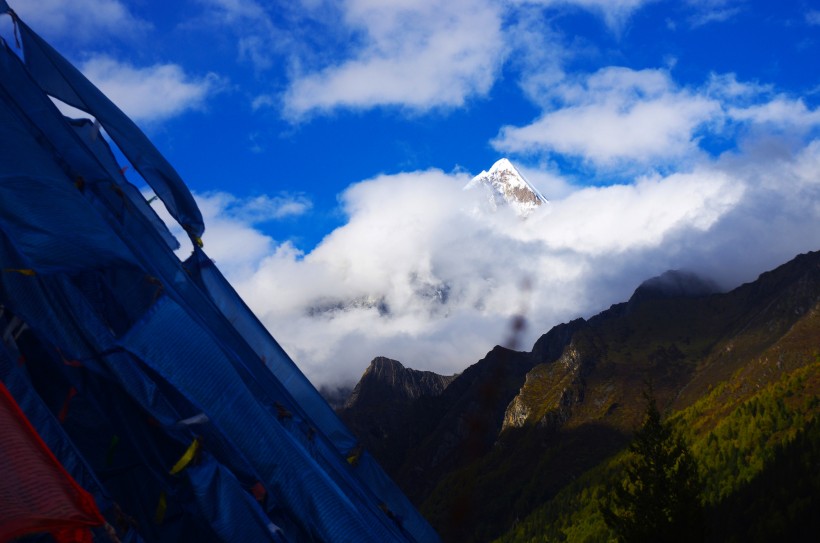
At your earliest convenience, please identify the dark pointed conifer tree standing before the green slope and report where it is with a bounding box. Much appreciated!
[601,387,704,543]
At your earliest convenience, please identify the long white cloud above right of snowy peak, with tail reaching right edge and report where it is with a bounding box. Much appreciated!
[492,67,820,171]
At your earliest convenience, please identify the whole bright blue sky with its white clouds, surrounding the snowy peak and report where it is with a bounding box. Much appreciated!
[3,0,820,384]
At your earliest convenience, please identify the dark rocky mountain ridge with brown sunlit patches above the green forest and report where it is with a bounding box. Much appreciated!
[338,252,820,541]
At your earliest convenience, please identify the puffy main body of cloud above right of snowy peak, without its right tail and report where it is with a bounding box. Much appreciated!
[493,67,720,167]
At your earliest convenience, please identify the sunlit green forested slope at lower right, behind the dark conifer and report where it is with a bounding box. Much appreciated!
[498,355,820,543]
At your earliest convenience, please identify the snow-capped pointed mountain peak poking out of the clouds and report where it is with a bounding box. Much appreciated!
[464,158,548,217]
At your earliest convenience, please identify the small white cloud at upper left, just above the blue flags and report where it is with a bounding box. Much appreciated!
[80,55,222,122]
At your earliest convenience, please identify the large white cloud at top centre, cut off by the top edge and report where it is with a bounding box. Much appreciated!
[284,0,506,118]
